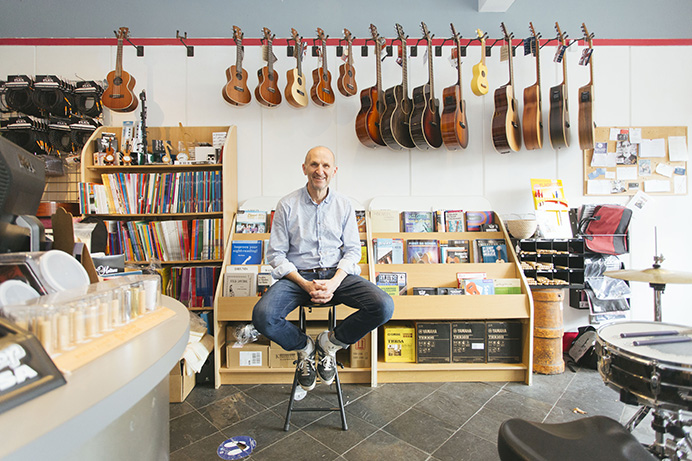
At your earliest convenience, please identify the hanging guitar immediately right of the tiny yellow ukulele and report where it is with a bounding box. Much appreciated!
[492,23,521,154]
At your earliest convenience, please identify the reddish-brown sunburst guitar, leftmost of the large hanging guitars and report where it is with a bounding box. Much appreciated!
[356,24,386,147]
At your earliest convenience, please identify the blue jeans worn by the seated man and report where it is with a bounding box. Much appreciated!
[252,269,394,351]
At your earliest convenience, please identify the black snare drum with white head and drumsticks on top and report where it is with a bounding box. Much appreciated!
[596,322,692,411]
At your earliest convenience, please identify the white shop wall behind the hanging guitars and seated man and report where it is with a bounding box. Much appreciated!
[0,38,692,329]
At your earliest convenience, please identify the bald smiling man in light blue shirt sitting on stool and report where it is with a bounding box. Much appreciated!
[252,146,394,390]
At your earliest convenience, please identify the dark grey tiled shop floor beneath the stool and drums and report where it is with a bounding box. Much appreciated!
[170,369,654,461]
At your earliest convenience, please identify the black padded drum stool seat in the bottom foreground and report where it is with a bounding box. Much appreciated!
[497,416,656,461]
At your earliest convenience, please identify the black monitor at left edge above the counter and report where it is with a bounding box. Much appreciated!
[0,136,46,253]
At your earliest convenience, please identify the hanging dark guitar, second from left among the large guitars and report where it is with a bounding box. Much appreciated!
[380,24,416,150]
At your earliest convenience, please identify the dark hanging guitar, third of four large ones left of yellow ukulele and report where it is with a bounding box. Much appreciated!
[409,22,442,149]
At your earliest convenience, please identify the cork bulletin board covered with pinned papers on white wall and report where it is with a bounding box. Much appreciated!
[584,126,689,195]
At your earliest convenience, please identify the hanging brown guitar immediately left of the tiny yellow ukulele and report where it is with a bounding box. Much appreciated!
[440,24,469,150]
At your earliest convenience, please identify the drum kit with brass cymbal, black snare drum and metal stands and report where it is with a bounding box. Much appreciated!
[596,256,692,460]
